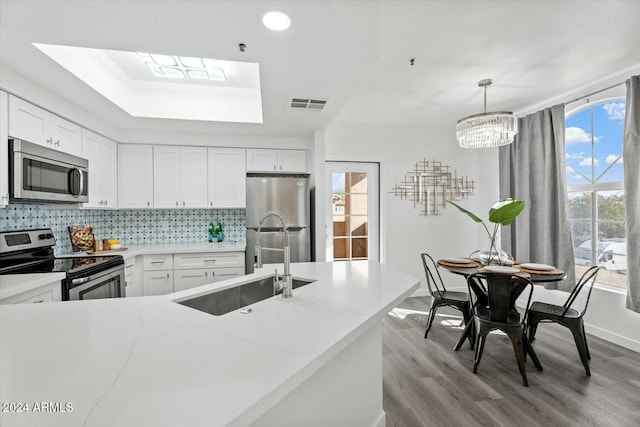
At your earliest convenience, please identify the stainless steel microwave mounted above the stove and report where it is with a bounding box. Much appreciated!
[9,139,89,203]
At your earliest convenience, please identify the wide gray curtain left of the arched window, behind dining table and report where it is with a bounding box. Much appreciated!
[499,105,575,290]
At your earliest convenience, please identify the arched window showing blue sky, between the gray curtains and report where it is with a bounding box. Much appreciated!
[565,99,627,288]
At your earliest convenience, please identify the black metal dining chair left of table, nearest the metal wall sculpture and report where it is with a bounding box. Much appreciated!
[420,253,474,350]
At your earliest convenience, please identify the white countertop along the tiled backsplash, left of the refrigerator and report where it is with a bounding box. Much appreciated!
[60,242,247,259]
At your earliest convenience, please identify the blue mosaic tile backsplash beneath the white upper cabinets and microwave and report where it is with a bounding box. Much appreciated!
[0,204,246,255]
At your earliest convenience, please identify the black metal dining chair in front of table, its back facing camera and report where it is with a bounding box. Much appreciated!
[467,273,542,386]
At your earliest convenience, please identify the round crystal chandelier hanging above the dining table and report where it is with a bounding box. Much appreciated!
[456,79,518,148]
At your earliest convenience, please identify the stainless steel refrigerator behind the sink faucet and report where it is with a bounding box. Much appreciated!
[246,175,311,274]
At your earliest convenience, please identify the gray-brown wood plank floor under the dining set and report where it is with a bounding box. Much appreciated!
[382,297,640,427]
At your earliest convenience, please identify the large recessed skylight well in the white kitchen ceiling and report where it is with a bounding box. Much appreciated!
[34,43,262,123]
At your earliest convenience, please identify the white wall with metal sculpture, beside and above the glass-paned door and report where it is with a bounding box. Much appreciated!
[325,122,498,293]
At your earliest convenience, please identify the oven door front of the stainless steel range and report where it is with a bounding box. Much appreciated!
[63,265,125,301]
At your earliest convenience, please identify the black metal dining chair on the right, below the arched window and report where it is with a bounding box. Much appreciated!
[527,266,600,376]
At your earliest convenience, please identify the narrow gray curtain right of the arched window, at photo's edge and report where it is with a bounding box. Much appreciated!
[622,76,640,313]
